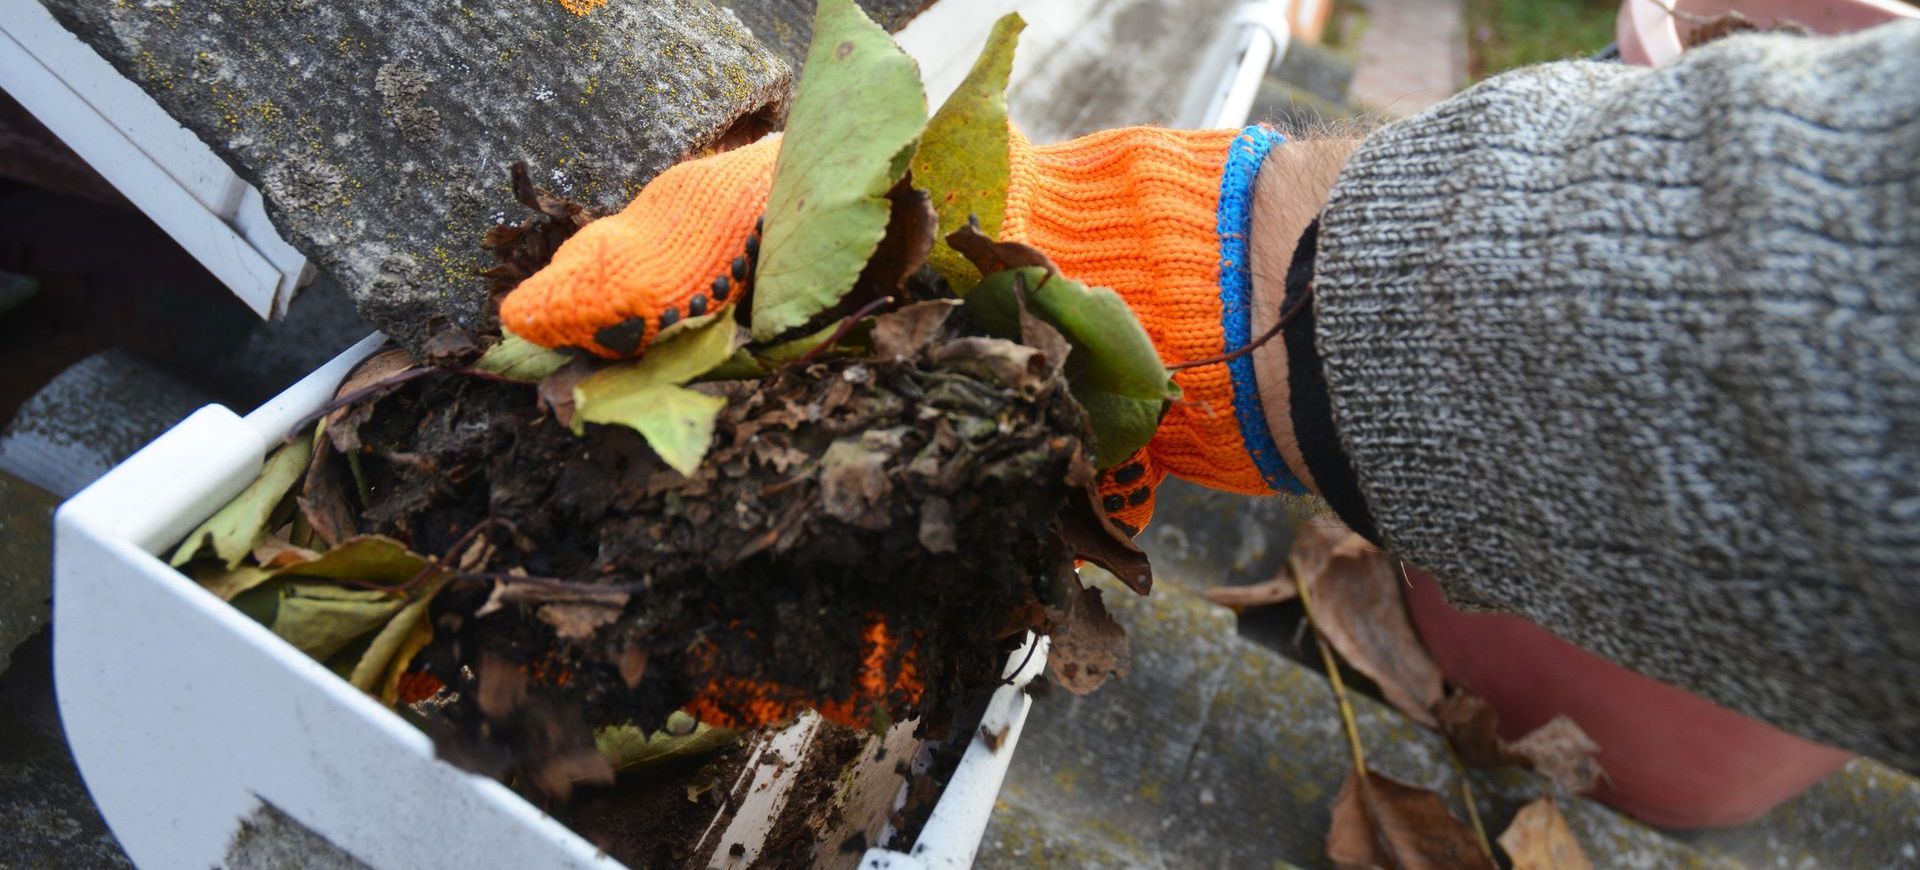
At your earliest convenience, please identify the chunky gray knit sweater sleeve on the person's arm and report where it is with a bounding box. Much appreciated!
[1313,21,1920,770]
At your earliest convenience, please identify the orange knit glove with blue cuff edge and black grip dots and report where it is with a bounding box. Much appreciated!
[501,127,1304,534]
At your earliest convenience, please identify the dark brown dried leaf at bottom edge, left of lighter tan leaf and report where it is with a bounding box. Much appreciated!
[1327,770,1494,870]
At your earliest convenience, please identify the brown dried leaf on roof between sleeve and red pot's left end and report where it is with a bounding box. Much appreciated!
[1288,522,1446,728]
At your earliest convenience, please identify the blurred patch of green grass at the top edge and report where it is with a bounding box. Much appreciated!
[1467,0,1619,81]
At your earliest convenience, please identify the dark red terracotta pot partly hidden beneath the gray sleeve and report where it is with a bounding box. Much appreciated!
[1407,568,1853,828]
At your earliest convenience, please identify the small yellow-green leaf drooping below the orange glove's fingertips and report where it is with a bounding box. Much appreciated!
[574,317,737,474]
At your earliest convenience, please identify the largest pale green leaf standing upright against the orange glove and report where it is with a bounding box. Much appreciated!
[753,0,927,342]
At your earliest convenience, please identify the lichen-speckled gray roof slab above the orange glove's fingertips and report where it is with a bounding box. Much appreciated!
[44,0,791,348]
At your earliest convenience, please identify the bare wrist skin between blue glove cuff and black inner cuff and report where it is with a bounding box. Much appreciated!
[1250,138,1359,494]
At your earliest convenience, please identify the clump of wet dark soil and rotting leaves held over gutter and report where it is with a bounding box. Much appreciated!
[301,163,1144,795]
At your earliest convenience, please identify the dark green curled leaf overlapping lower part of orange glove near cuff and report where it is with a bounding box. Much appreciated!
[966,267,1179,469]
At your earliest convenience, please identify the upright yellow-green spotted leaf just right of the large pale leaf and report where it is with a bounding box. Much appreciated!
[914,12,1027,296]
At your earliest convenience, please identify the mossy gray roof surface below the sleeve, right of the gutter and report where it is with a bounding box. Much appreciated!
[975,480,1920,870]
